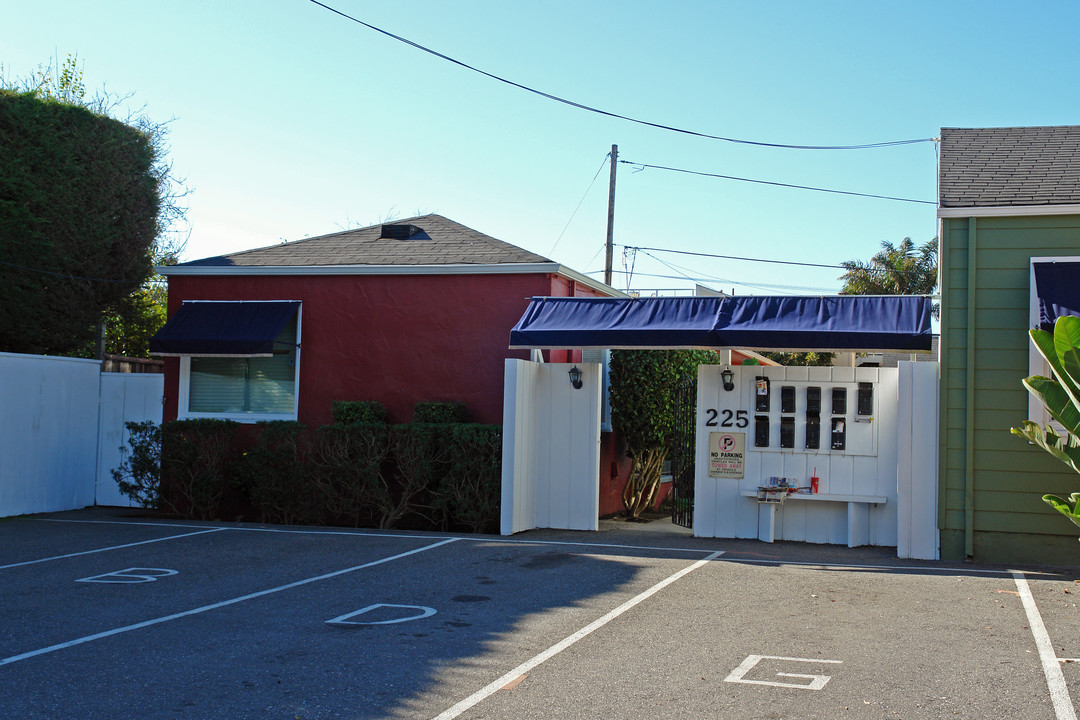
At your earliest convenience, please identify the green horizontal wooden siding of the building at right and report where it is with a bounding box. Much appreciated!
[939,216,1080,563]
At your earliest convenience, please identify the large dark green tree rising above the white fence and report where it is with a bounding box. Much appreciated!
[0,56,187,356]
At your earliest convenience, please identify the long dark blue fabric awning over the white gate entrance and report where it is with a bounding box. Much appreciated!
[510,296,931,352]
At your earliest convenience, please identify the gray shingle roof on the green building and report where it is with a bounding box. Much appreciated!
[939,125,1080,207]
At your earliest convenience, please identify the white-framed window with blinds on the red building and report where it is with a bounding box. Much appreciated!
[188,316,297,416]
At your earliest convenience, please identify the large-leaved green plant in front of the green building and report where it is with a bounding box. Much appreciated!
[1012,316,1080,535]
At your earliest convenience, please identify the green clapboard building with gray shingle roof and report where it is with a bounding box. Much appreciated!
[937,125,1080,565]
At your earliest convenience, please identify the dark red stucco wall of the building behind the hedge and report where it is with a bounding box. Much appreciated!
[164,273,609,426]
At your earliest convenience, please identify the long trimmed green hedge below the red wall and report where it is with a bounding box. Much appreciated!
[128,420,502,532]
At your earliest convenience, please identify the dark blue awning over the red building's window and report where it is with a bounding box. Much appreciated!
[150,300,300,357]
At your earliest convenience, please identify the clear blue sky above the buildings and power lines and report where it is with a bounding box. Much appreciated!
[0,0,1080,295]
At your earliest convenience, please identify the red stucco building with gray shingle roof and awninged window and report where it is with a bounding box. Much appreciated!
[153,215,622,426]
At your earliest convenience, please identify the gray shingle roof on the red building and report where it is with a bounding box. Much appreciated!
[177,215,551,268]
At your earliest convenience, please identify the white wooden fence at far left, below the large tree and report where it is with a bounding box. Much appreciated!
[0,353,164,517]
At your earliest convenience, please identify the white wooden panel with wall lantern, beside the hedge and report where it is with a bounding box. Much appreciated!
[502,359,602,534]
